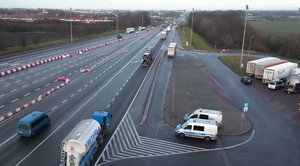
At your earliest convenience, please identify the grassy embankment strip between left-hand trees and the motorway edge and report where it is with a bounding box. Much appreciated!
[0,31,117,57]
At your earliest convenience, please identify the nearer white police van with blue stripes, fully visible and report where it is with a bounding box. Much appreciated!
[175,118,218,141]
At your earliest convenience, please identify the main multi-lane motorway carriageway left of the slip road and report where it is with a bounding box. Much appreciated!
[0,28,161,166]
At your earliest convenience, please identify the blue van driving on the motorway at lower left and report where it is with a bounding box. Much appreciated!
[18,111,50,137]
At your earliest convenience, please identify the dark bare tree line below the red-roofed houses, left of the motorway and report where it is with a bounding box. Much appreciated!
[0,11,151,51]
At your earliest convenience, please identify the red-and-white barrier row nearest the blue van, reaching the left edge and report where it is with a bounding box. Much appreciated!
[0,79,70,123]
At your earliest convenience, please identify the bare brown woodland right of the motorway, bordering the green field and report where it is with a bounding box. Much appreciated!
[188,11,300,60]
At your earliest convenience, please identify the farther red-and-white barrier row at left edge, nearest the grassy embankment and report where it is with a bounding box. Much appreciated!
[0,54,72,77]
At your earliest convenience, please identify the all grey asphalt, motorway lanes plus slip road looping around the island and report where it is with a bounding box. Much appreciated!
[0,24,300,166]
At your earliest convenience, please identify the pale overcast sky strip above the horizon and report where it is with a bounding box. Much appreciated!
[0,0,300,10]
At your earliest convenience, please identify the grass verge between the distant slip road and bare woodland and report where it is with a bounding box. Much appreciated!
[177,26,214,51]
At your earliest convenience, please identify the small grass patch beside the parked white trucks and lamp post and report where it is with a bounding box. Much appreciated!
[219,56,258,75]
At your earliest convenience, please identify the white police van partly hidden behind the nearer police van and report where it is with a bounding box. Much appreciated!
[184,108,223,127]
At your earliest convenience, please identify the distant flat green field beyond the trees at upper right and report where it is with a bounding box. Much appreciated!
[249,20,300,36]
